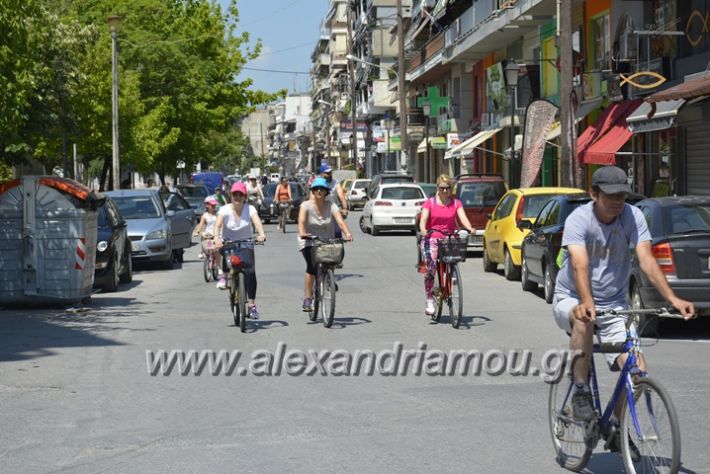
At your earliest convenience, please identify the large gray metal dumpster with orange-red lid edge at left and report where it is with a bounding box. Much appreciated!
[0,176,104,305]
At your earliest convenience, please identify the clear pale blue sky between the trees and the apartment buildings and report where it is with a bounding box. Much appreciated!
[219,0,330,97]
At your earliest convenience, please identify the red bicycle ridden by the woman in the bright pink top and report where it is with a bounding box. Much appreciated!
[424,229,468,328]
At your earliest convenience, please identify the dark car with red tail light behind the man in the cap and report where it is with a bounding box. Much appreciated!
[629,196,710,335]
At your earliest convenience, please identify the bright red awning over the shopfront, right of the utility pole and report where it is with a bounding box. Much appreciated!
[577,99,641,164]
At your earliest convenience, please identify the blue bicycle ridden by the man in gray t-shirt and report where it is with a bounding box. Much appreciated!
[548,308,681,473]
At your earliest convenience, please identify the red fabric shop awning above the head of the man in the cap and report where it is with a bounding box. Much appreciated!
[577,99,641,164]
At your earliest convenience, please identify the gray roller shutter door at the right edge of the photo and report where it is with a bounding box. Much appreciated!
[683,121,710,196]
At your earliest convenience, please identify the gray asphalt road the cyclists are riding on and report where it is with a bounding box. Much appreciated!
[0,213,710,474]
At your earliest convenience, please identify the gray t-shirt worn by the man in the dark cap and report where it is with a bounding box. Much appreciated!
[555,202,651,308]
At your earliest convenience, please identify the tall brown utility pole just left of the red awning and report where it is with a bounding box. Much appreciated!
[557,0,582,187]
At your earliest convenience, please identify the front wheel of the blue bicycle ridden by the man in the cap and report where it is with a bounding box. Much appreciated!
[620,377,680,474]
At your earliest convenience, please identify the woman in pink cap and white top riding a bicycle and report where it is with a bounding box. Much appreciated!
[215,182,266,319]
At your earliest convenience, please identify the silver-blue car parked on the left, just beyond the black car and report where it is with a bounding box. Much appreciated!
[106,189,195,263]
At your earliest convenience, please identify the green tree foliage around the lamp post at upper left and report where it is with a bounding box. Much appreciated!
[0,0,285,189]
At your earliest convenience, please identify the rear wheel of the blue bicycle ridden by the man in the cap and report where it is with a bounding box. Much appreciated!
[547,376,592,472]
